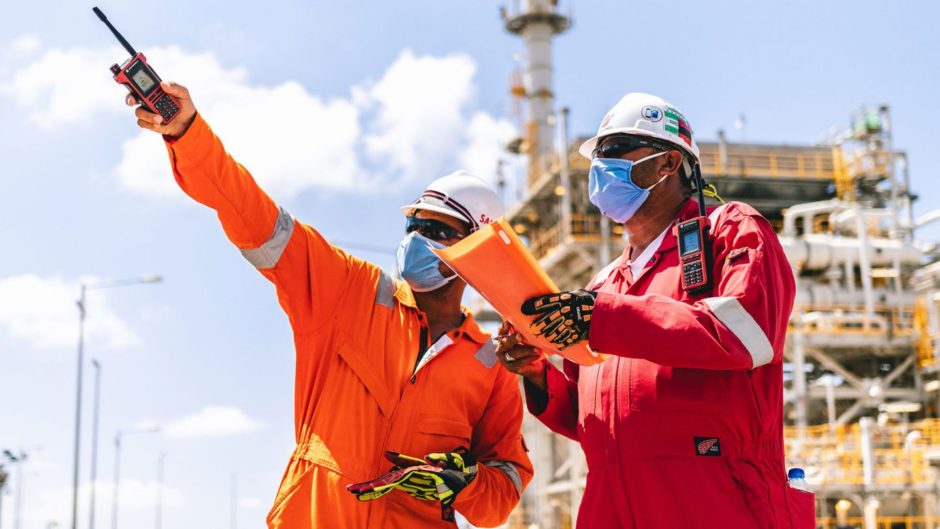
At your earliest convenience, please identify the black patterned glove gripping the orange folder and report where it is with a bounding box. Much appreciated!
[522,290,597,349]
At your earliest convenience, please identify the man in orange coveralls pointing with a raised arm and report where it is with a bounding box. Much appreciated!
[128,83,532,529]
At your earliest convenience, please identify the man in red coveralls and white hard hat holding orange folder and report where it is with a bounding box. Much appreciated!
[498,93,815,529]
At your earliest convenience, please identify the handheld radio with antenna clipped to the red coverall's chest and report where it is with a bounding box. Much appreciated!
[673,164,713,295]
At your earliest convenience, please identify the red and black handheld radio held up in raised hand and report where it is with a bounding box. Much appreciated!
[92,7,180,123]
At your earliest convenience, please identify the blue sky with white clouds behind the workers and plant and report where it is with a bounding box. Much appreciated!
[0,0,940,529]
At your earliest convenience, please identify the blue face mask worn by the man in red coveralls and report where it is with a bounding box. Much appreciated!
[588,152,669,224]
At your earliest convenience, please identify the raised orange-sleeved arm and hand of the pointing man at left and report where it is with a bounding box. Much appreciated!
[129,83,368,329]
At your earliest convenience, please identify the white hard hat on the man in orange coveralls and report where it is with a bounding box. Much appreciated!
[401,170,503,232]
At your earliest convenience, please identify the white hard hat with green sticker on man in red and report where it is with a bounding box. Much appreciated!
[578,92,699,168]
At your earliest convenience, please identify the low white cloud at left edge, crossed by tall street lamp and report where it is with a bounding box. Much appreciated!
[0,274,140,348]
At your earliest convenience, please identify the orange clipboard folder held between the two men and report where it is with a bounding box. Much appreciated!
[434,217,606,366]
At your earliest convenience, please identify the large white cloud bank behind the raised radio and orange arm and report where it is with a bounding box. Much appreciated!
[0,42,511,199]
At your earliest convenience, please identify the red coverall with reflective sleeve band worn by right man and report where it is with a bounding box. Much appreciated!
[526,200,815,529]
